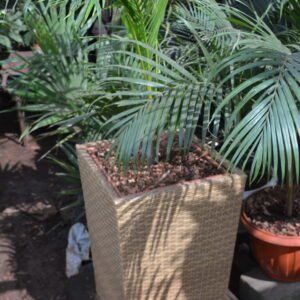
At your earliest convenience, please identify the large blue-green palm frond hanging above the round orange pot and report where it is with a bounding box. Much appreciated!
[213,45,300,182]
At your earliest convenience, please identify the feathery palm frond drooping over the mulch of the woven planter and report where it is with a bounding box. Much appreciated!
[105,42,221,168]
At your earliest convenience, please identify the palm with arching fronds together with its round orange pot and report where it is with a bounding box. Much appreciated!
[210,1,300,281]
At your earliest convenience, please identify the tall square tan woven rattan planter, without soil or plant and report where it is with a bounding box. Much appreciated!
[77,144,246,300]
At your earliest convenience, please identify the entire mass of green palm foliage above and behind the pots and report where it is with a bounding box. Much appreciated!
[0,0,300,214]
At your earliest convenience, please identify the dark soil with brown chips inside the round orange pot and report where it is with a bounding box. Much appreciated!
[245,187,300,236]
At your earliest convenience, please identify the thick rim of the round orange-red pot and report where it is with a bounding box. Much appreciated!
[241,206,300,247]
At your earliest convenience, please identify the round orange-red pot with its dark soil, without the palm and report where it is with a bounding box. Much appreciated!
[241,187,300,282]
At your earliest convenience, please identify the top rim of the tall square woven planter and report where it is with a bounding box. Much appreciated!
[76,142,246,200]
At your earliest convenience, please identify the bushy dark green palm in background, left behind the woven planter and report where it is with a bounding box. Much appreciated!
[12,1,112,152]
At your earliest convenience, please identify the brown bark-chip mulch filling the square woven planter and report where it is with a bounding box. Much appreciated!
[87,141,226,196]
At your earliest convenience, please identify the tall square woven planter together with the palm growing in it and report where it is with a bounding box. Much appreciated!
[77,1,246,300]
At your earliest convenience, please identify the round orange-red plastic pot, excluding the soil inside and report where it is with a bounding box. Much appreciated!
[241,209,300,282]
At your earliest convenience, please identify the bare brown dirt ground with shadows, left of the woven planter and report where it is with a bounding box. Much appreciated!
[0,106,70,300]
